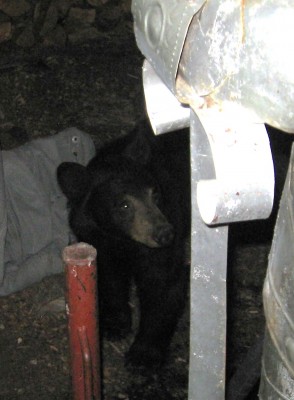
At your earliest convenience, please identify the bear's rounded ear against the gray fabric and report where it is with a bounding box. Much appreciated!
[57,162,90,202]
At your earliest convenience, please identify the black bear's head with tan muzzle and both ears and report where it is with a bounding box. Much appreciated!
[57,125,174,248]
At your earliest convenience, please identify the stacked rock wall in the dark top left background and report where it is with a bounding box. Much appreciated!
[0,0,131,48]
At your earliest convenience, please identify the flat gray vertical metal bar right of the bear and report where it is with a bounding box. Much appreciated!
[189,111,228,400]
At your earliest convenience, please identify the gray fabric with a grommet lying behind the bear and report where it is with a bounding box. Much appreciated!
[0,128,95,296]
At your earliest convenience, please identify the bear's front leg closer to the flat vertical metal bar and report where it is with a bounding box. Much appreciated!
[126,267,187,368]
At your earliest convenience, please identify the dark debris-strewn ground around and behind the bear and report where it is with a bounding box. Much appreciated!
[0,3,292,400]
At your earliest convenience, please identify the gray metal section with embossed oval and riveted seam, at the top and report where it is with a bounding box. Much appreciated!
[132,0,205,91]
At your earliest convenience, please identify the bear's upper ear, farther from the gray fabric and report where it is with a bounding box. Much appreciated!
[123,120,154,165]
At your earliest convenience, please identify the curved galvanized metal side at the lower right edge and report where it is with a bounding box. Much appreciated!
[259,147,294,400]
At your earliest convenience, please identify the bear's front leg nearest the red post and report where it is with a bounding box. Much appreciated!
[98,267,132,339]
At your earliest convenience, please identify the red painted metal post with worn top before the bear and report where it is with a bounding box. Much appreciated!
[63,243,101,400]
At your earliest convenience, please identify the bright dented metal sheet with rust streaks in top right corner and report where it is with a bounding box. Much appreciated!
[177,0,294,133]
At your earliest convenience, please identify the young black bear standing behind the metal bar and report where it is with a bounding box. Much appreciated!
[57,123,190,367]
